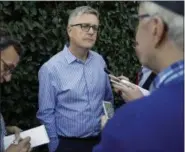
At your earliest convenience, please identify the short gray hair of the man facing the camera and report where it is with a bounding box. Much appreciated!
[68,6,99,25]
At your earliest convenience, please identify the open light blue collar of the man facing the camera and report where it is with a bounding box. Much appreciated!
[63,44,93,64]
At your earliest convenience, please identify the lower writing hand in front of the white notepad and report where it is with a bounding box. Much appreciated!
[5,137,31,152]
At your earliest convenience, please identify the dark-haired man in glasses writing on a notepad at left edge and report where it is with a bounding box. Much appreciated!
[0,30,30,152]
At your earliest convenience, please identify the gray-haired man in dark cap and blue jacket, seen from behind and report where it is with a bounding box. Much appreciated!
[93,1,184,152]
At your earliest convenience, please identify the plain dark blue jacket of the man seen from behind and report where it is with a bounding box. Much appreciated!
[93,80,184,152]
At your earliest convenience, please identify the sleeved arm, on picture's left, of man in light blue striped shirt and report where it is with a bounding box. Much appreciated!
[37,65,59,152]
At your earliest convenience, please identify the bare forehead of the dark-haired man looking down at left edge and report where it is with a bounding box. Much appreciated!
[1,46,20,63]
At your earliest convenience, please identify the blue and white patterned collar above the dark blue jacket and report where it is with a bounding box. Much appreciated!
[153,60,184,89]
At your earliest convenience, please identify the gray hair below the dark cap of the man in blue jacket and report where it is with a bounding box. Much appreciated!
[140,2,184,50]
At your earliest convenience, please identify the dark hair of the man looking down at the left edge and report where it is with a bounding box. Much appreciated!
[0,29,23,56]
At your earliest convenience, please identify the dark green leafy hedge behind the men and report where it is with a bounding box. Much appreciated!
[0,1,139,151]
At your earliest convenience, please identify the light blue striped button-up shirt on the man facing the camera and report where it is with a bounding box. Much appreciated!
[37,46,113,151]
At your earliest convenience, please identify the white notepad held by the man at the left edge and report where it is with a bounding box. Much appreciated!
[4,125,49,149]
